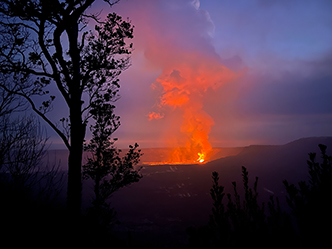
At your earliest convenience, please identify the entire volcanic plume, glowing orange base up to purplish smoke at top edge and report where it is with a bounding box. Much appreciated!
[116,0,238,164]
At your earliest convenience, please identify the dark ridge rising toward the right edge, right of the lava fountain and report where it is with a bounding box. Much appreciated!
[206,137,332,200]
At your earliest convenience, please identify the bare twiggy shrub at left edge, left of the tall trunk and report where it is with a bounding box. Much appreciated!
[0,71,59,197]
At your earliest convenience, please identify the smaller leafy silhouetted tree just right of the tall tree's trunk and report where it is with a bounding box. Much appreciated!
[83,98,142,230]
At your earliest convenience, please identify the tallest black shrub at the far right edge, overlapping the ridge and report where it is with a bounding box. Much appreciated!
[284,144,332,248]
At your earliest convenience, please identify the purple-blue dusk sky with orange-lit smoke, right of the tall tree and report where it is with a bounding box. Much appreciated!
[49,0,332,148]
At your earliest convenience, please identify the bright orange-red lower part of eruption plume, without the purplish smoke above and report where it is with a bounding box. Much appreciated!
[149,53,236,164]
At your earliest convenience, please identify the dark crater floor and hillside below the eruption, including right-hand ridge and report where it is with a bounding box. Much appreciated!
[106,137,332,245]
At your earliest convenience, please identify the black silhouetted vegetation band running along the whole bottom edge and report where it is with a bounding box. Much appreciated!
[0,145,332,248]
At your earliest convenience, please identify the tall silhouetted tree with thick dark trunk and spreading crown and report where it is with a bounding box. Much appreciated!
[0,0,133,216]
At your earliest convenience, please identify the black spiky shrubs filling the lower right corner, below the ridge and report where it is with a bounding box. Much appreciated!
[187,144,332,248]
